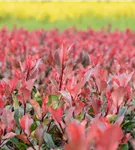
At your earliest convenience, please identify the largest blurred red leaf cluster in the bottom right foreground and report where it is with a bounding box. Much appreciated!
[87,118,123,150]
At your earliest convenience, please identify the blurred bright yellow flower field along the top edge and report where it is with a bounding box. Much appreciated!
[0,0,135,21]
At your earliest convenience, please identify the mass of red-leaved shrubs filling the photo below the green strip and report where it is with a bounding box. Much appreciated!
[0,28,135,150]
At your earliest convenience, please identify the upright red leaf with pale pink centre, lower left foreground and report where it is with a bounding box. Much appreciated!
[19,114,33,136]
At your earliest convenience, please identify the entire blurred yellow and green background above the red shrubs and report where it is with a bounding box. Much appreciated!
[0,0,135,30]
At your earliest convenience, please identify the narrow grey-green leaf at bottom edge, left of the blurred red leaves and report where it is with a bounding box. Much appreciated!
[44,132,56,148]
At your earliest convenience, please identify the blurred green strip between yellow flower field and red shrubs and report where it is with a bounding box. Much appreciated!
[0,17,135,30]
